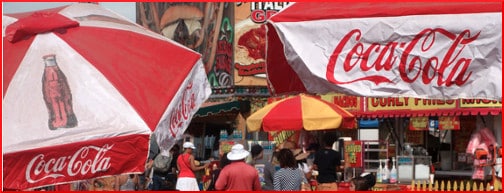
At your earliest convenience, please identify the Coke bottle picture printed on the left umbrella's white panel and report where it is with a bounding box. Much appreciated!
[42,54,77,130]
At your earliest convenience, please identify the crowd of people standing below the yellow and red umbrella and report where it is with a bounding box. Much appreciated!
[141,132,374,191]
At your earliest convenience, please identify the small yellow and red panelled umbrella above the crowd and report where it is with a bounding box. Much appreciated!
[247,94,356,132]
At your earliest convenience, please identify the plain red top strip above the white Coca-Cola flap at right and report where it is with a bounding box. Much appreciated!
[270,1,502,22]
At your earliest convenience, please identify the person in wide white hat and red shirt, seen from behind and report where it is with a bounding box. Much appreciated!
[215,144,261,191]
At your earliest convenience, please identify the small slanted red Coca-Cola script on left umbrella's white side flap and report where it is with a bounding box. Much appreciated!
[170,82,196,137]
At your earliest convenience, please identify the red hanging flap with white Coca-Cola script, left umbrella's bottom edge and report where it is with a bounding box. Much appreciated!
[3,135,149,189]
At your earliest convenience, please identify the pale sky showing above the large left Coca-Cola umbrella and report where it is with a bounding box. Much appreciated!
[2,2,136,22]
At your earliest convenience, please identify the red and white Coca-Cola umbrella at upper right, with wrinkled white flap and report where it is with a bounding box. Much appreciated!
[266,2,502,101]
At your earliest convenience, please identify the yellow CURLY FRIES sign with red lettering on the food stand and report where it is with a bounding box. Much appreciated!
[367,97,457,111]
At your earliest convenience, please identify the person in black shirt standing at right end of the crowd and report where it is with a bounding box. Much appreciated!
[313,134,341,191]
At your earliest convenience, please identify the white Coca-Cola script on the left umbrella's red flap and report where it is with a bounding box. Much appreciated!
[25,144,114,183]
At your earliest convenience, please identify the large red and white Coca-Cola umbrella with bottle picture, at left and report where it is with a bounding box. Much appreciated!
[2,3,211,189]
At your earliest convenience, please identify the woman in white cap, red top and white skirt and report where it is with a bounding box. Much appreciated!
[176,142,210,191]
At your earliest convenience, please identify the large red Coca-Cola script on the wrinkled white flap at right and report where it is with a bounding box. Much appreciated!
[326,28,480,87]
